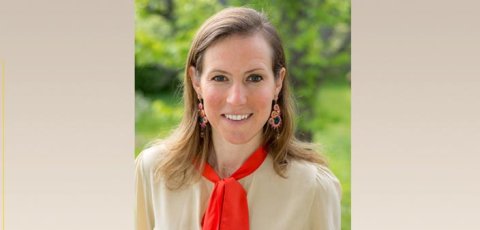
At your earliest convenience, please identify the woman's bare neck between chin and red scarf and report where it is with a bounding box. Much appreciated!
[208,131,261,178]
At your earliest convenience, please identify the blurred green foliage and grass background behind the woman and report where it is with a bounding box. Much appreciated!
[135,0,351,230]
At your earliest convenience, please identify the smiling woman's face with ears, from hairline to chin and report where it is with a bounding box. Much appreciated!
[189,34,285,144]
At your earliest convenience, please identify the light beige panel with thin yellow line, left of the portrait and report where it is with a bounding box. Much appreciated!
[0,0,134,230]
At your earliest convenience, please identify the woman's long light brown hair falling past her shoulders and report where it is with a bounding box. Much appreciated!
[155,7,326,189]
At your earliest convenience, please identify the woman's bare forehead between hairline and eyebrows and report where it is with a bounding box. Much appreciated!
[203,33,273,71]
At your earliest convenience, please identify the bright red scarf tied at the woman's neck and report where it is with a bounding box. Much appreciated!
[202,146,267,230]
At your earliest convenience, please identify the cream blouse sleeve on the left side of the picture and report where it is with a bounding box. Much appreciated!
[135,151,154,230]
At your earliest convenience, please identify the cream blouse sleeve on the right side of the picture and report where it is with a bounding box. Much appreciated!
[310,166,342,230]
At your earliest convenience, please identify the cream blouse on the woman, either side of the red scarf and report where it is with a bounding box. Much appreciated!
[135,147,341,230]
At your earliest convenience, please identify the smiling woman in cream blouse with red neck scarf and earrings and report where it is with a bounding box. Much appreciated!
[136,8,340,230]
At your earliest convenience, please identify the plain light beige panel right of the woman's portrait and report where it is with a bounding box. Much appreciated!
[352,0,480,230]
